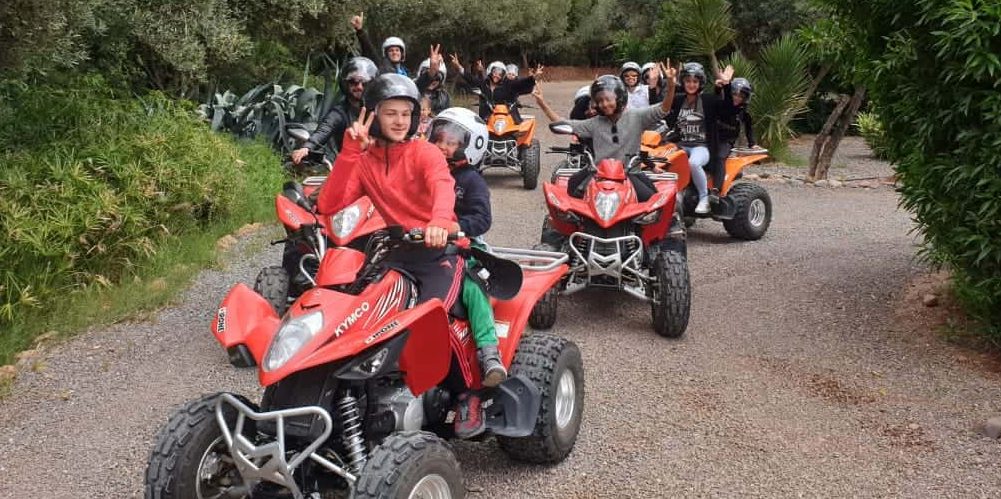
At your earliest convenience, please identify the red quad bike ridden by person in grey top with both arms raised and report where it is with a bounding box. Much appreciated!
[538,124,692,338]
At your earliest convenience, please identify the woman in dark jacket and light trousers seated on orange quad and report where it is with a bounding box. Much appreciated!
[665,62,733,214]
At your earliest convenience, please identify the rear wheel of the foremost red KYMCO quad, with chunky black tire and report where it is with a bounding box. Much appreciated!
[496,333,584,464]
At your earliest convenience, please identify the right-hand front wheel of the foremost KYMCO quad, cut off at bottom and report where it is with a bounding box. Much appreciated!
[351,431,465,499]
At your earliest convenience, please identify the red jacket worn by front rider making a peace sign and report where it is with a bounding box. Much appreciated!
[316,134,455,230]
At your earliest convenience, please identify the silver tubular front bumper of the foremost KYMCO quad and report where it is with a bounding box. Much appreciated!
[215,393,357,499]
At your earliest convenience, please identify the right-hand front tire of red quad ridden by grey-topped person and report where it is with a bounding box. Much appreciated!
[651,250,692,338]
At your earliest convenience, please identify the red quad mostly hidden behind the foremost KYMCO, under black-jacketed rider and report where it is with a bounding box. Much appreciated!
[253,170,385,315]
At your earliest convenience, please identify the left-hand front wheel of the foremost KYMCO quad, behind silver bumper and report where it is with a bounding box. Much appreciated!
[143,394,257,499]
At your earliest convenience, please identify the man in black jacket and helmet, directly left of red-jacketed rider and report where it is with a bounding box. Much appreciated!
[291,57,378,164]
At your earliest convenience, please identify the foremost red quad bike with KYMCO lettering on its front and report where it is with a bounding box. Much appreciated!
[145,227,584,498]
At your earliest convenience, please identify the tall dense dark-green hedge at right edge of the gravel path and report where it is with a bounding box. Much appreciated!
[830,0,1001,339]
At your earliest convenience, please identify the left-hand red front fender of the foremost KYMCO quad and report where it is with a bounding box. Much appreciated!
[212,283,280,364]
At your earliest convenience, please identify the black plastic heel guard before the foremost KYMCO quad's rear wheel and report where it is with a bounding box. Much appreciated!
[483,374,543,437]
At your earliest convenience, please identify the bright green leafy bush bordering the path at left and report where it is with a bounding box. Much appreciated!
[0,79,281,363]
